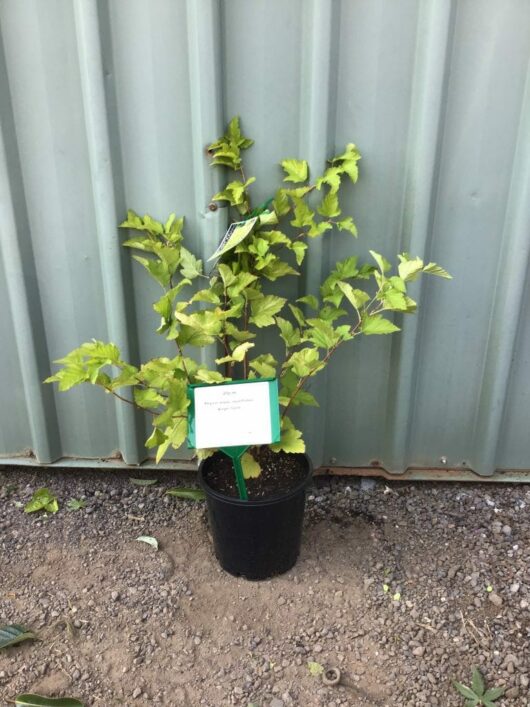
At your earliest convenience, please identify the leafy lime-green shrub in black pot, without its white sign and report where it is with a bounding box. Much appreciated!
[46,118,450,579]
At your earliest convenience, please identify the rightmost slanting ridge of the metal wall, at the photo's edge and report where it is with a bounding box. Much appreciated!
[471,64,530,476]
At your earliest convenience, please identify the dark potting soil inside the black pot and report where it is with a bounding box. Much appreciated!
[204,447,307,500]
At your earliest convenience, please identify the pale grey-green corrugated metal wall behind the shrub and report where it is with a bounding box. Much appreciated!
[0,0,530,475]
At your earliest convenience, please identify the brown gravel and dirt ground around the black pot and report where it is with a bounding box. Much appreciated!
[0,469,530,707]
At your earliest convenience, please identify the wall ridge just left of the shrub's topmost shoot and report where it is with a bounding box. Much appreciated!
[186,0,224,374]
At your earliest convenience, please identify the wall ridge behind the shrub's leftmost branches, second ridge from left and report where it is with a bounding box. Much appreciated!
[74,0,145,464]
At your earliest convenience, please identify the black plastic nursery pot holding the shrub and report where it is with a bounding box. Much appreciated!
[199,455,313,580]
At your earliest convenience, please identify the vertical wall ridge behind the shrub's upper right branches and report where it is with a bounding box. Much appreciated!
[299,0,334,466]
